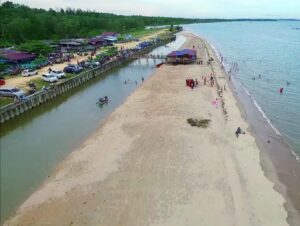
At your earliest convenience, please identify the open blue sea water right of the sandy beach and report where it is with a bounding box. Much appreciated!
[184,21,300,156]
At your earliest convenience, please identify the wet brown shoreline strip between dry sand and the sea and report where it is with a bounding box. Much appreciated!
[194,34,300,226]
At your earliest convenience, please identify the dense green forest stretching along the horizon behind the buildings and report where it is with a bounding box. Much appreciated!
[0,1,276,47]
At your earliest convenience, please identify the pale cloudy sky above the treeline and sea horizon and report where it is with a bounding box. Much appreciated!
[6,0,300,19]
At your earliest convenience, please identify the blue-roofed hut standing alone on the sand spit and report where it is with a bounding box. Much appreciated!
[166,49,197,64]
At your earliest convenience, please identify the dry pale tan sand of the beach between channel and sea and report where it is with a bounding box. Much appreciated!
[5,33,287,226]
